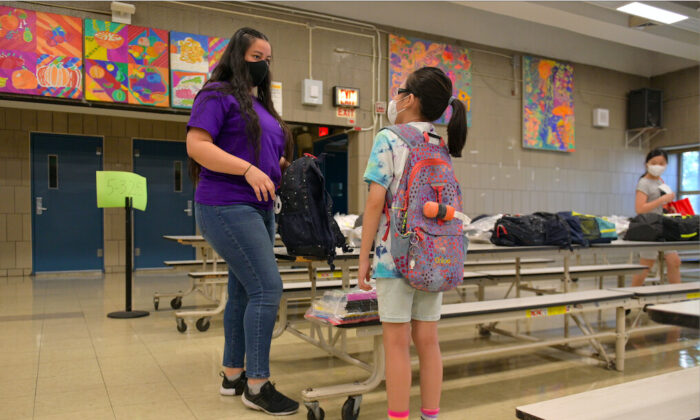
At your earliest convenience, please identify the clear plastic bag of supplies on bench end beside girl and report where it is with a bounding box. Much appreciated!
[304,288,379,325]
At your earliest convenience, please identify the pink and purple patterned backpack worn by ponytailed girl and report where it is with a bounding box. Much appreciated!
[384,124,469,292]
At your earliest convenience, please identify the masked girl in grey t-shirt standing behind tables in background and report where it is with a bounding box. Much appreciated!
[632,149,681,287]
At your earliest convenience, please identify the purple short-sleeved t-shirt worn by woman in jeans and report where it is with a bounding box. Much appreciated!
[187,84,285,209]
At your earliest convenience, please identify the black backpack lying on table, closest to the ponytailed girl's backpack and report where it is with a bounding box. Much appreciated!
[491,215,545,246]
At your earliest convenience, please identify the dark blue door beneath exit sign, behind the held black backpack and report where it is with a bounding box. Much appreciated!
[314,134,348,214]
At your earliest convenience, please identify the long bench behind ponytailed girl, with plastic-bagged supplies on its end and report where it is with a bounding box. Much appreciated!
[302,290,633,420]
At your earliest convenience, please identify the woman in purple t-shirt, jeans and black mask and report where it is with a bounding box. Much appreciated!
[187,28,299,415]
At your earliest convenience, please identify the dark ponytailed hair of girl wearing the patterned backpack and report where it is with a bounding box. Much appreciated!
[406,67,467,157]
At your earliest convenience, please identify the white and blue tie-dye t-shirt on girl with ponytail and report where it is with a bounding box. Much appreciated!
[364,122,435,278]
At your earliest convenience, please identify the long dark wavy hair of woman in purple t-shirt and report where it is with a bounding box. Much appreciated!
[189,28,294,184]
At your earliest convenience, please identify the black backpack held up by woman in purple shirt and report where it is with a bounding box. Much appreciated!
[278,155,350,269]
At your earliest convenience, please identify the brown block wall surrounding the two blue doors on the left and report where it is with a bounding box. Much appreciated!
[0,108,185,276]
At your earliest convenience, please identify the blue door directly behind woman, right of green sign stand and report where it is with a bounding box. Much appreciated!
[133,139,195,268]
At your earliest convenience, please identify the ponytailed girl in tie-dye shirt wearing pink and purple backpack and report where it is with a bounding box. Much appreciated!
[358,67,467,420]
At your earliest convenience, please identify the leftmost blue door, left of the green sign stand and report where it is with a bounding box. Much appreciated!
[30,133,104,273]
